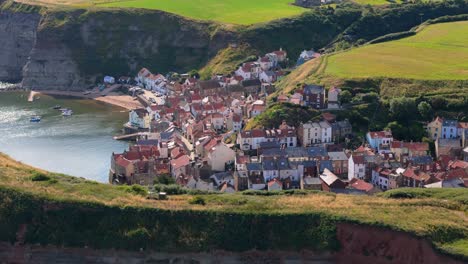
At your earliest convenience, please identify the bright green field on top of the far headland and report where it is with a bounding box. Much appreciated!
[97,0,306,25]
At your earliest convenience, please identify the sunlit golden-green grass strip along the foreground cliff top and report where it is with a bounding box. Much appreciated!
[0,154,468,256]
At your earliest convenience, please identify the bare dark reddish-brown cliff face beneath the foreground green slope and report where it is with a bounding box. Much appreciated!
[0,223,461,264]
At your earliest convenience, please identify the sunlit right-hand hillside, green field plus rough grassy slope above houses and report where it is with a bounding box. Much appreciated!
[276,21,468,98]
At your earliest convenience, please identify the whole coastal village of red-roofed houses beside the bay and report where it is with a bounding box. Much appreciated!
[106,49,468,194]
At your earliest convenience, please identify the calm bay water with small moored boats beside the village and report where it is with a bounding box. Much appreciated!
[0,92,128,182]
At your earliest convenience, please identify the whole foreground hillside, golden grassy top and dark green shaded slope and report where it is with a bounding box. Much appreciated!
[0,155,468,261]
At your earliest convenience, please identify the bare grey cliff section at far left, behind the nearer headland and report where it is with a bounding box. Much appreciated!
[0,11,40,82]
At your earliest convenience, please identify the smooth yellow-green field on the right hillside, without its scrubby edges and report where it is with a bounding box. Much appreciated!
[324,21,468,80]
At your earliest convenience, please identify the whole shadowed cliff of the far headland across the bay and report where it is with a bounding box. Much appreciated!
[0,5,235,90]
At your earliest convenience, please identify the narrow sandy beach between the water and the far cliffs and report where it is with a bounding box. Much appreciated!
[33,90,143,110]
